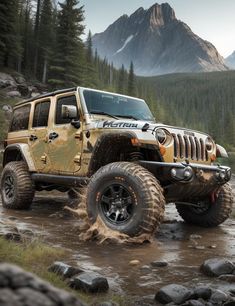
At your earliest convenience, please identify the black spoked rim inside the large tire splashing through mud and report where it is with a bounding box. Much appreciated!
[99,183,134,225]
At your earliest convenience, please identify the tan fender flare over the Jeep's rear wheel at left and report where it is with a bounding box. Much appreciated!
[3,143,36,172]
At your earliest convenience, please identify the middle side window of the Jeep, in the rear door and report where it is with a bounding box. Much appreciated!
[33,101,50,127]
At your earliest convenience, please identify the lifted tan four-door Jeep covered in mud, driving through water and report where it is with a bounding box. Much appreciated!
[1,87,233,236]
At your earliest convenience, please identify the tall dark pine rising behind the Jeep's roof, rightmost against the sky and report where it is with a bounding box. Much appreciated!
[49,0,84,88]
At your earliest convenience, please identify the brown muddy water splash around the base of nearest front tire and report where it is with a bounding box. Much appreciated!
[64,188,153,244]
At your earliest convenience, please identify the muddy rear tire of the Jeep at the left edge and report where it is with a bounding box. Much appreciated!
[1,161,34,209]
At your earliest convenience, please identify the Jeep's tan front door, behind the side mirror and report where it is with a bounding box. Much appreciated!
[47,93,82,174]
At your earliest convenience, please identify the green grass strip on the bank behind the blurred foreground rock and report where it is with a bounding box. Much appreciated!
[0,237,128,306]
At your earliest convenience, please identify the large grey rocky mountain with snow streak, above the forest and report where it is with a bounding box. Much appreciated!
[92,3,228,76]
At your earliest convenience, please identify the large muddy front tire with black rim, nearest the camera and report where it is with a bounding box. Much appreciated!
[87,162,165,236]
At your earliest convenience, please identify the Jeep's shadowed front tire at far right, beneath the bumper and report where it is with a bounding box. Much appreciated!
[176,183,233,227]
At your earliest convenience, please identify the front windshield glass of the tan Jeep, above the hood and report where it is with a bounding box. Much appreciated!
[83,90,154,121]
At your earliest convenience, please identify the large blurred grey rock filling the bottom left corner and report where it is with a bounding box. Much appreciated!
[0,264,84,306]
